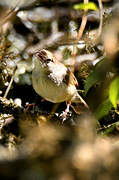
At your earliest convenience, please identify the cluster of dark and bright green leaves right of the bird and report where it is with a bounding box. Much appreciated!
[84,60,119,120]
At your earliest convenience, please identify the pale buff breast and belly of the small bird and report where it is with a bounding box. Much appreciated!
[32,68,76,103]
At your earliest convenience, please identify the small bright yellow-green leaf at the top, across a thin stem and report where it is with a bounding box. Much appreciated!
[74,2,98,11]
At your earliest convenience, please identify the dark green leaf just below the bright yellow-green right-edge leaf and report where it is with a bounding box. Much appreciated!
[95,99,113,120]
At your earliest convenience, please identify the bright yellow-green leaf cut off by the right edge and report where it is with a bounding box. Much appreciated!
[109,76,119,108]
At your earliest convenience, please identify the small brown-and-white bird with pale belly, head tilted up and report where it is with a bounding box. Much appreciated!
[32,49,89,116]
